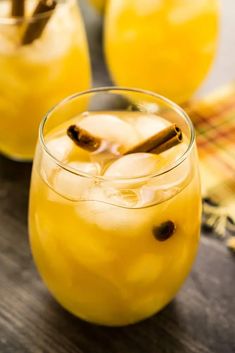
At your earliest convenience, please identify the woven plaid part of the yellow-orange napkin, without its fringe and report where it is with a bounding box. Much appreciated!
[186,84,235,219]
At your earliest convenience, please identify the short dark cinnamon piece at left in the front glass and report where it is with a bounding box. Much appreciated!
[67,125,102,152]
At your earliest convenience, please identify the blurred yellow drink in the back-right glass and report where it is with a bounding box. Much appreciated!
[104,0,218,103]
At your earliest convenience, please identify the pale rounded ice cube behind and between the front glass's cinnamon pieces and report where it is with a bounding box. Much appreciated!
[79,112,140,148]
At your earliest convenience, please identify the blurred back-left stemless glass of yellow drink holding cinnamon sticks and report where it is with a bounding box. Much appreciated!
[0,0,90,160]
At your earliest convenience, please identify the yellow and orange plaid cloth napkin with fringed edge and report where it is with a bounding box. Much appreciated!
[185,83,235,250]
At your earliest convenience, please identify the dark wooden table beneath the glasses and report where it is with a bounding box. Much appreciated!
[0,0,235,353]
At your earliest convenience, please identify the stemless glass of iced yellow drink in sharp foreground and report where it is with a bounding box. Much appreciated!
[29,88,201,326]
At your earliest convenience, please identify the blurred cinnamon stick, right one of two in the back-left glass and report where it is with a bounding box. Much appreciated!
[21,0,57,45]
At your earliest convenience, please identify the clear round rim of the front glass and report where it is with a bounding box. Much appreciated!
[39,86,195,182]
